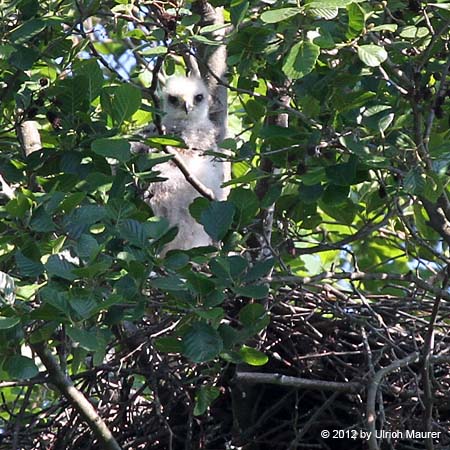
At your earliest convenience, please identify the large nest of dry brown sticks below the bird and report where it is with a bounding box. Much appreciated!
[0,283,450,450]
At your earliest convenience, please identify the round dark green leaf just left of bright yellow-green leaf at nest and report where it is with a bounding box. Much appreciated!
[183,322,223,363]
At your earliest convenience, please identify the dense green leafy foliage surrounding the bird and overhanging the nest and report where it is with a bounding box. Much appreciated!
[0,0,450,448]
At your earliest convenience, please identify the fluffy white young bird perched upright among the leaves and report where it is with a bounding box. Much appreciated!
[144,76,231,255]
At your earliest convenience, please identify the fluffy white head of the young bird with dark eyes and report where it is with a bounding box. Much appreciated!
[163,76,209,122]
